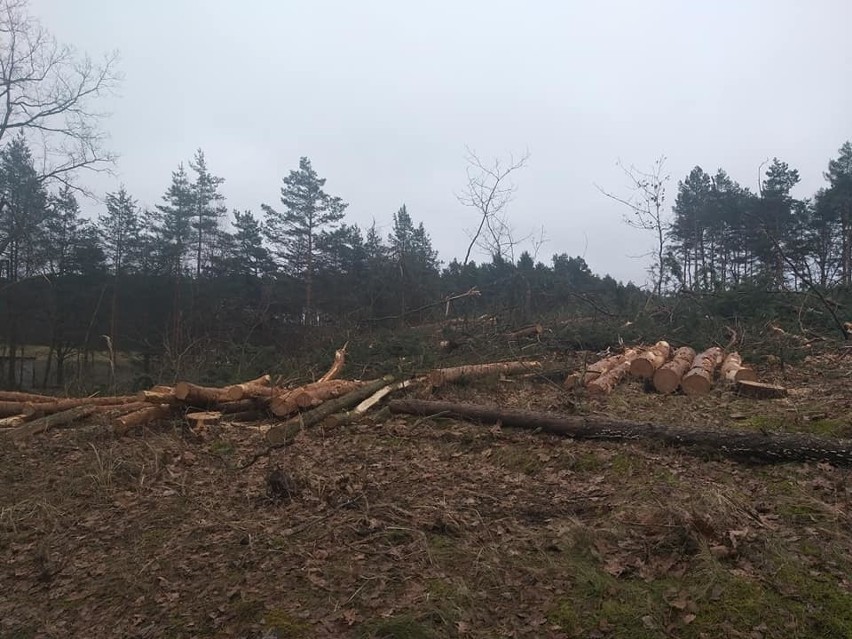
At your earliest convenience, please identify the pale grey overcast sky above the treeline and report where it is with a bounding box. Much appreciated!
[32,0,852,283]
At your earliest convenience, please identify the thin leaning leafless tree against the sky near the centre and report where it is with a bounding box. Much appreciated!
[456,148,530,264]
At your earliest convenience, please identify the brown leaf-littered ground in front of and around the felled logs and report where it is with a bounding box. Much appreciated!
[0,354,852,639]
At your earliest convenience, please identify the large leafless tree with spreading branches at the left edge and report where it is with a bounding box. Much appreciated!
[0,0,120,253]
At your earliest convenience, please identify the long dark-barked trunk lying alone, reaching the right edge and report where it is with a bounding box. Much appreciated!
[390,399,852,466]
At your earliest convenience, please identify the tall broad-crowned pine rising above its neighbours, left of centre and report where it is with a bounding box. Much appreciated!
[263,157,348,323]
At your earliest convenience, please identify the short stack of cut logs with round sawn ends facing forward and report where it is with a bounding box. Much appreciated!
[565,342,786,398]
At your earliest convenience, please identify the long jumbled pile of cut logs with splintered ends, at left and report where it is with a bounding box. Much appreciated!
[0,347,541,443]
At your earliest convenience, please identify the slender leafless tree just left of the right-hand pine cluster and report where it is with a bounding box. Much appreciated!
[595,155,671,295]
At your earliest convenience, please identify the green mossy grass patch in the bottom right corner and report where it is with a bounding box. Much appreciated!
[548,553,852,639]
